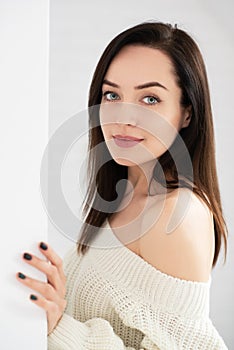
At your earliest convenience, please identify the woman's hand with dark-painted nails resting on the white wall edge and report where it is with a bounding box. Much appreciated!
[16,242,67,334]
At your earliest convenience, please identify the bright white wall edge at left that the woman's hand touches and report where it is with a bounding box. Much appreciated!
[0,0,49,350]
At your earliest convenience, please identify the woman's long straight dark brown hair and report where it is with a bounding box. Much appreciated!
[77,21,228,267]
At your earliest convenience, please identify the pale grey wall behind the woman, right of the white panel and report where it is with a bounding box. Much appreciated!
[49,0,234,349]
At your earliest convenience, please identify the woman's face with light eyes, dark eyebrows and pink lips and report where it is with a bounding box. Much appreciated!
[100,45,190,166]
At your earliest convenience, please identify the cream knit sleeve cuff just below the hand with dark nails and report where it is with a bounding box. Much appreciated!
[47,248,152,350]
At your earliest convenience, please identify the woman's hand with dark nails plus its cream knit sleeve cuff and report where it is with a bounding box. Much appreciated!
[16,243,148,350]
